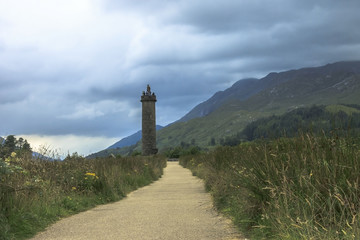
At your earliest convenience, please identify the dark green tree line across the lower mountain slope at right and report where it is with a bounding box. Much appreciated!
[220,104,360,146]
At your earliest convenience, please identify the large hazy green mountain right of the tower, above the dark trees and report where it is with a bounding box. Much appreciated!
[157,61,360,150]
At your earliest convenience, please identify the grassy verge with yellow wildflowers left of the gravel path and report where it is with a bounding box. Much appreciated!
[0,153,166,239]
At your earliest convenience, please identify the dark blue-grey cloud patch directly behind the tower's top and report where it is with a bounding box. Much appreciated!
[72,67,214,114]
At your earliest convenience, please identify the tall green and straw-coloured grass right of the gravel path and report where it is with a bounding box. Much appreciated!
[180,134,360,239]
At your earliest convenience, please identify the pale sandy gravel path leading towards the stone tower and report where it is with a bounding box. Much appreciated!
[33,162,242,240]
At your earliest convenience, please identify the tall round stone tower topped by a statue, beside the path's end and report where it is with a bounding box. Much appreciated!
[141,85,158,156]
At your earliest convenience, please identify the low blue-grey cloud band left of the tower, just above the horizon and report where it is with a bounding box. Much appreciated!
[0,98,139,136]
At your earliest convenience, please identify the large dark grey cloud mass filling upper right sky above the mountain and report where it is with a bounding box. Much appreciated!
[128,0,360,76]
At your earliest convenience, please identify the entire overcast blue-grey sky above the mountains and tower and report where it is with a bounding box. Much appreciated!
[0,0,360,155]
